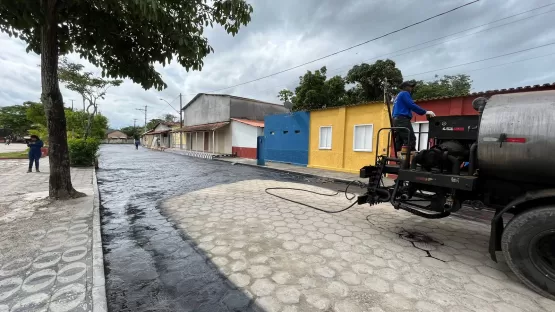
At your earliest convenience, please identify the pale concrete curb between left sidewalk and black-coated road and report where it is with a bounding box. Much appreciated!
[92,170,108,312]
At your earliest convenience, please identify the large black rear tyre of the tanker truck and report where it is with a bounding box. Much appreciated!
[501,206,555,300]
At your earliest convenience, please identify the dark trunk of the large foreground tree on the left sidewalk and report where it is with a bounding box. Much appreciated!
[41,0,85,199]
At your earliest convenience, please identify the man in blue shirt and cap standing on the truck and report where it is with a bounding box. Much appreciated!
[393,81,435,151]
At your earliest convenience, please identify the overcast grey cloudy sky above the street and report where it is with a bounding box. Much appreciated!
[0,0,555,128]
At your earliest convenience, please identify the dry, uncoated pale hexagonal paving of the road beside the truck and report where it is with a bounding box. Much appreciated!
[164,180,555,312]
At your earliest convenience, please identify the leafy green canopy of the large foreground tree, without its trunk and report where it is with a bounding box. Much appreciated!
[0,0,253,90]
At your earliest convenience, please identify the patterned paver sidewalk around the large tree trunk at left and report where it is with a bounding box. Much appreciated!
[0,159,96,312]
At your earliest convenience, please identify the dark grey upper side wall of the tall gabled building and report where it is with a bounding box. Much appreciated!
[229,97,288,120]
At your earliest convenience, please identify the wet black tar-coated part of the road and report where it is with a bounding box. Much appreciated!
[97,145,352,312]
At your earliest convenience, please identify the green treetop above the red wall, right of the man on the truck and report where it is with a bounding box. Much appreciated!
[412,74,472,100]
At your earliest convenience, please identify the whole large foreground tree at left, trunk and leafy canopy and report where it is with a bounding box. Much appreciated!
[0,0,252,199]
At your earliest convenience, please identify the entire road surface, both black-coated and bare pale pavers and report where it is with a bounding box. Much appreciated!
[97,146,555,312]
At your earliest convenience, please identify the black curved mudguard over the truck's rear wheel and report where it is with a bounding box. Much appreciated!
[489,189,555,262]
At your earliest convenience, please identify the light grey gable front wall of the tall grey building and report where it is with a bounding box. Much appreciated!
[183,94,230,126]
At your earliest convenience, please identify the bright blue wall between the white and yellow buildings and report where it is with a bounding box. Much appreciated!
[264,112,310,166]
